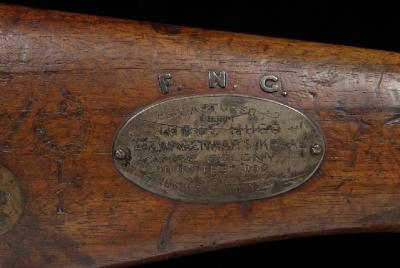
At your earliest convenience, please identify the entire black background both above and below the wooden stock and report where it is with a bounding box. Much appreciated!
[1,0,400,268]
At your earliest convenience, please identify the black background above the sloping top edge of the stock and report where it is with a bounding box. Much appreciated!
[0,0,400,51]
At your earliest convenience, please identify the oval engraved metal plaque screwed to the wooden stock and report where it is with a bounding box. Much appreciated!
[113,95,325,203]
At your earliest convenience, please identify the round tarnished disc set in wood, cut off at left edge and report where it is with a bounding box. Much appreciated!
[0,166,25,234]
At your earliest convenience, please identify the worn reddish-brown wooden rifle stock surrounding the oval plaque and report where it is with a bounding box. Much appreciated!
[0,5,400,267]
